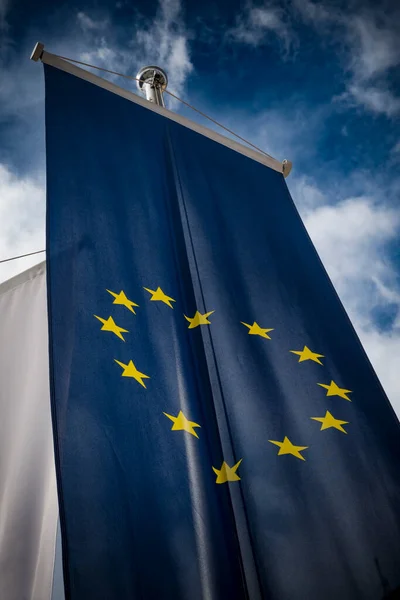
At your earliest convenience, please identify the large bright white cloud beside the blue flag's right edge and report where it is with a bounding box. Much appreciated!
[292,177,400,408]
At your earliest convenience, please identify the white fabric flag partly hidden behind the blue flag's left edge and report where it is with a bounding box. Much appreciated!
[0,263,58,600]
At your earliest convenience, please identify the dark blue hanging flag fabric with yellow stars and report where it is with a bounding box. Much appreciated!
[45,66,400,600]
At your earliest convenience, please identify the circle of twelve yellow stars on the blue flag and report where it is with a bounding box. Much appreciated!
[94,287,352,484]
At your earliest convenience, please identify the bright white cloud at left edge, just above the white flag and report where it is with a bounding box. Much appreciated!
[0,163,45,281]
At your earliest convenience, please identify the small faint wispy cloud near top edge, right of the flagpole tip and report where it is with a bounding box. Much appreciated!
[226,5,295,53]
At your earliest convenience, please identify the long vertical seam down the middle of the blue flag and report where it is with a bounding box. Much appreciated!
[167,127,262,600]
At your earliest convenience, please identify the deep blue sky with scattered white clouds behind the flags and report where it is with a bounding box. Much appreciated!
[0,0,400,408]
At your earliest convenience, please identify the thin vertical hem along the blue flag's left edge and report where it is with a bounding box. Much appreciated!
[44,65,71,600]
